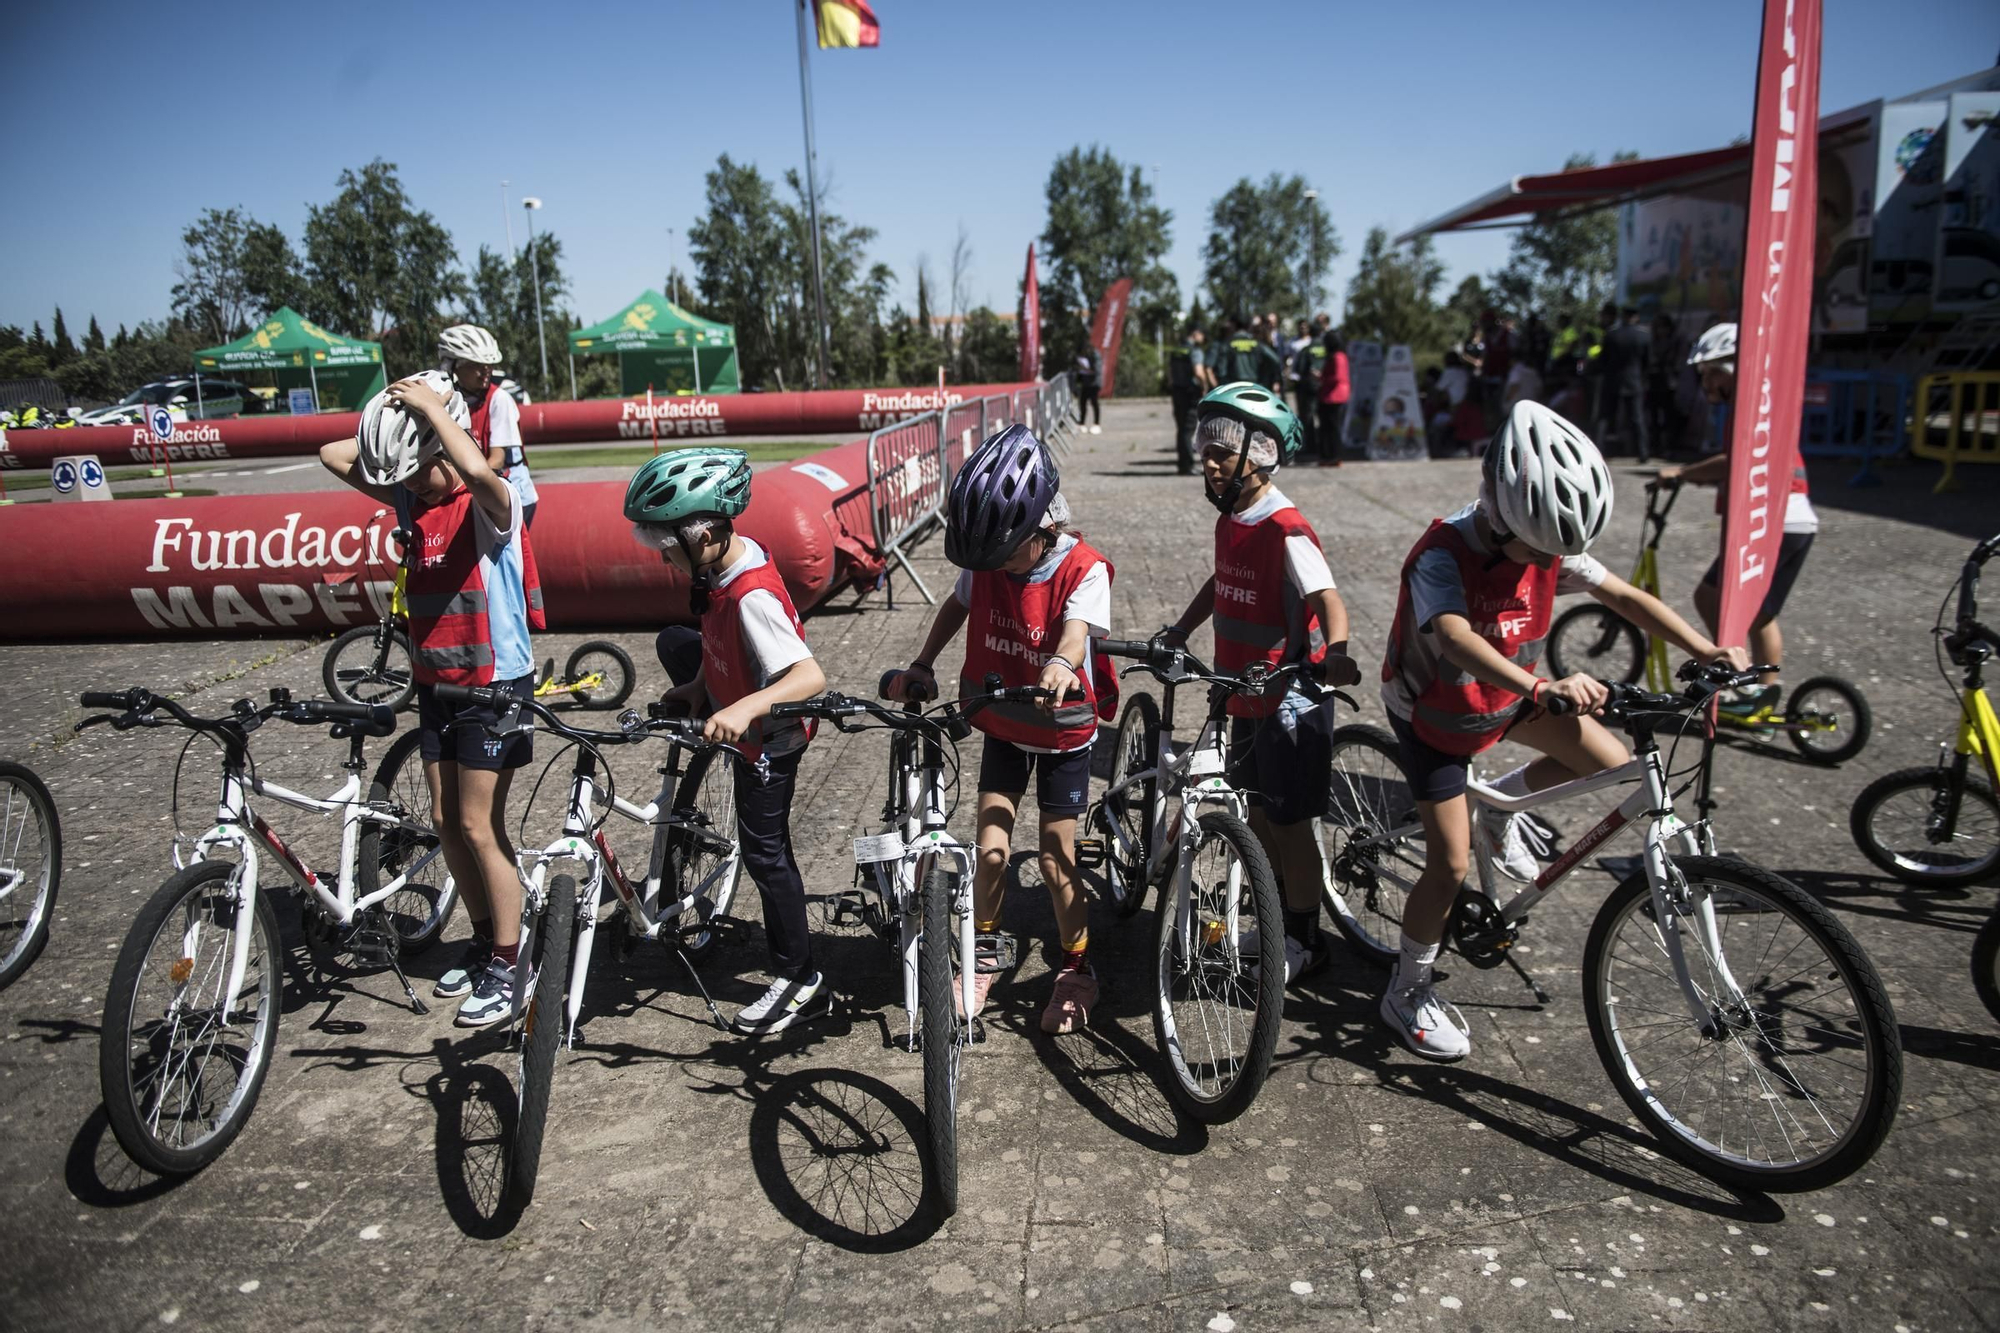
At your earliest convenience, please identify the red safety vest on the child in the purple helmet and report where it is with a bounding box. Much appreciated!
[958,542,1118,753]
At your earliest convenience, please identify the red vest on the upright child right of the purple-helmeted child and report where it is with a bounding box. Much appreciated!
[1214,504,1326,717]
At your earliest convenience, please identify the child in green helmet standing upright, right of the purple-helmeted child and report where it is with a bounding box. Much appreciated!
[1166,382,1362,985]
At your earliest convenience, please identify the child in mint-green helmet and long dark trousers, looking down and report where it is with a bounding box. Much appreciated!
[624,446,826,1035]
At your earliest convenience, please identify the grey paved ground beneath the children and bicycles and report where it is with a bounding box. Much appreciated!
[0,404,2000,1333]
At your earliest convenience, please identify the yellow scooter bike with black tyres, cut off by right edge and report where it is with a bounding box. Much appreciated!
[1848,536,2000,889]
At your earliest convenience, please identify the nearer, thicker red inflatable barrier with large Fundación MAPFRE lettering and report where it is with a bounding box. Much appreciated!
[0,440,882,640]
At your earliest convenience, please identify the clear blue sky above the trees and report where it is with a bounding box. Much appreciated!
[0,0,2000,334]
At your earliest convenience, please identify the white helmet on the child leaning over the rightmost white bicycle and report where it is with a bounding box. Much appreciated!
[1480,400,1612,556]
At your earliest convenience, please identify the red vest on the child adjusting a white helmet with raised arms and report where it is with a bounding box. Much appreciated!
[400,486,548,685]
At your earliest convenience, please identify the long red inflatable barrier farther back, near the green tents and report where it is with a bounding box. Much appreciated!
[0,384,1032,468]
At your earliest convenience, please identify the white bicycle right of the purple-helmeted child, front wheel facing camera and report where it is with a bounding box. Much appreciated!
[1076,638,1354,1125]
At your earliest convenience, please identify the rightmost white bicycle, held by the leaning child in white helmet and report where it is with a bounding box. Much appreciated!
[1326,664,1902,1191]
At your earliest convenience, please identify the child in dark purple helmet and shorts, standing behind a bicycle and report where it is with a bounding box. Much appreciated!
[892,426,1112,1033]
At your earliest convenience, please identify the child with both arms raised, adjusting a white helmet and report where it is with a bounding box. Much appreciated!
[320,370,542,1027]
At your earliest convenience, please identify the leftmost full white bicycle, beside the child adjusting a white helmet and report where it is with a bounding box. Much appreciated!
[76,689,456,1177]
